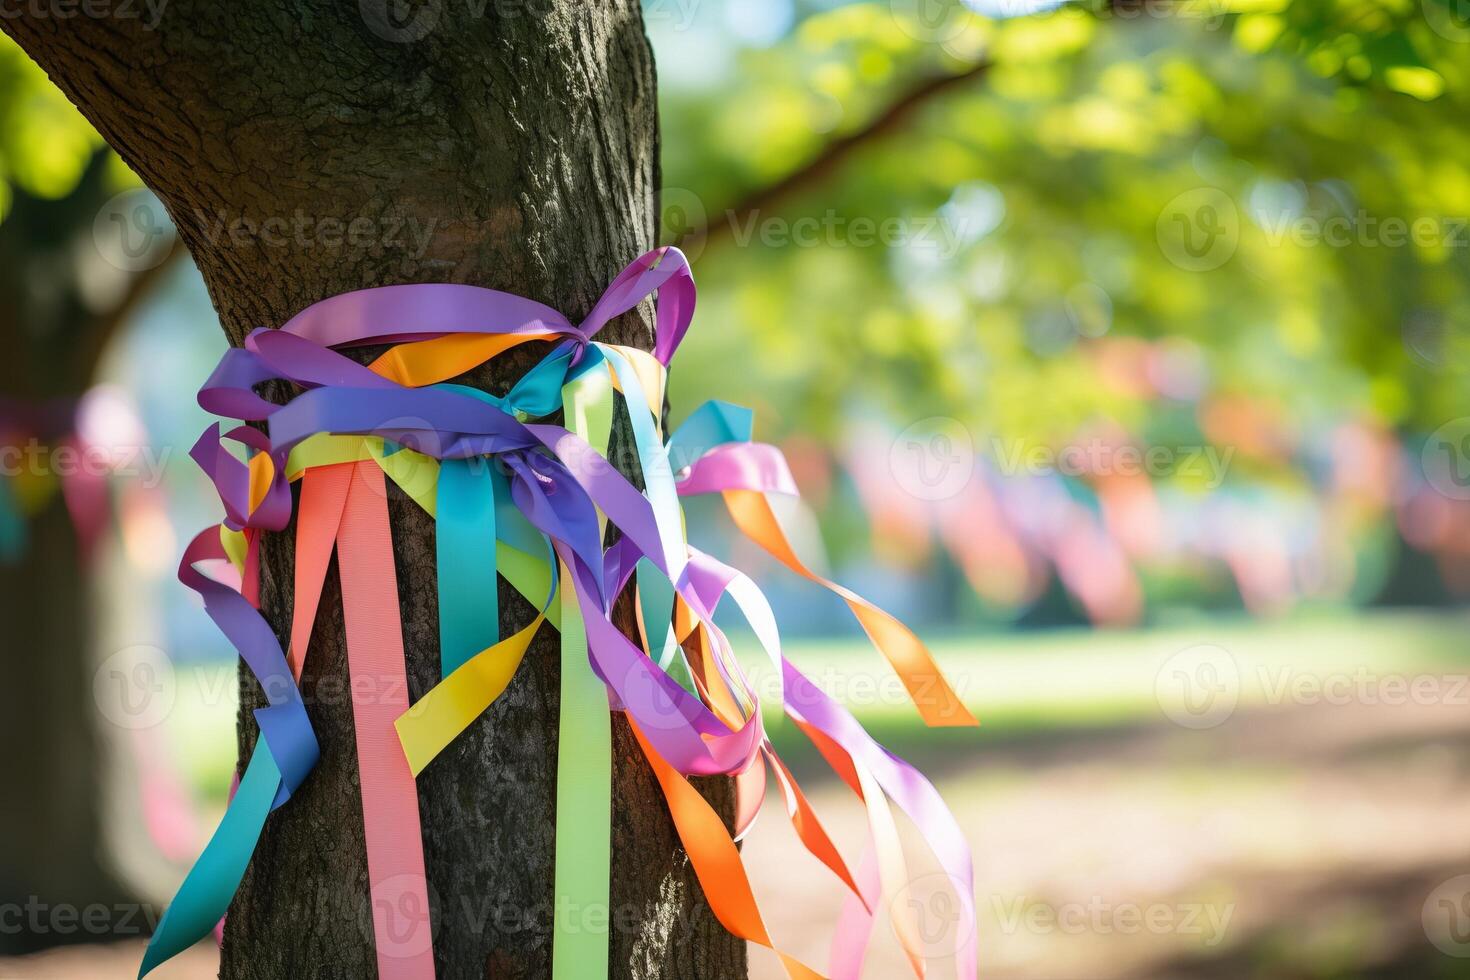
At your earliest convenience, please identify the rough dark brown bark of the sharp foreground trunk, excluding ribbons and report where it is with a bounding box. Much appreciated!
[0,7,745,980]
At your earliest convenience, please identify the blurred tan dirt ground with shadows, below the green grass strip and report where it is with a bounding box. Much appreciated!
[0,704,1470,980]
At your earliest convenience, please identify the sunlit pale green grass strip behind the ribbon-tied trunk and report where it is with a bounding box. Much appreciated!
[166,613,1470,799]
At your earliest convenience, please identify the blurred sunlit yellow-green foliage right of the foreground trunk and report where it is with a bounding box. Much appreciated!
[656,0,1470,442]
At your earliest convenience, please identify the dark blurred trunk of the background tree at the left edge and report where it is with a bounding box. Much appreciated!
[0,155,141,955]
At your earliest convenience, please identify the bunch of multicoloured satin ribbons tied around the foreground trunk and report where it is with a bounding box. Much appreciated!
[140,248,975,980]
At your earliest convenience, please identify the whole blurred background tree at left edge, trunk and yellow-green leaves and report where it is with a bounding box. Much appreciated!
[0,38,172,952]
